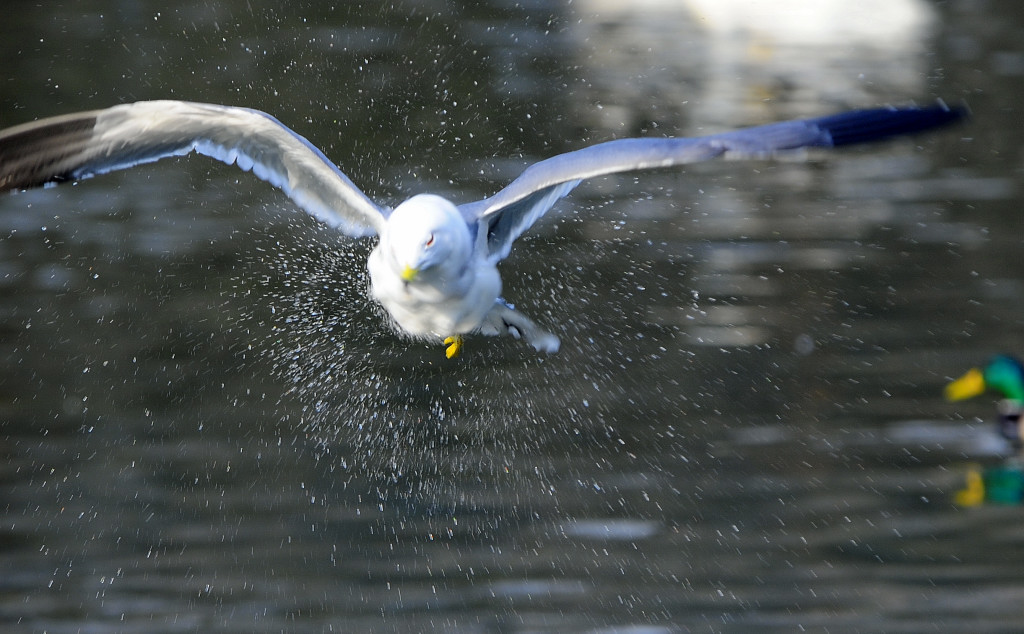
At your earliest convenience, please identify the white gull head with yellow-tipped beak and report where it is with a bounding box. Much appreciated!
[386,194,473,284]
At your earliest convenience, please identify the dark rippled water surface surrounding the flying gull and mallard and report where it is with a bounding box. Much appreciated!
[0,0,1024,632]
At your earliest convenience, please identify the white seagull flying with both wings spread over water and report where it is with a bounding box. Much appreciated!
[0,100,967,358]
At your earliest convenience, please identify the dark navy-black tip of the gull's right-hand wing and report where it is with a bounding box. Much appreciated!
[812,101,970,146]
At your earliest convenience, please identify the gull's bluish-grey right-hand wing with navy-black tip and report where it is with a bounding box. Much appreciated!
[459,102,967,261]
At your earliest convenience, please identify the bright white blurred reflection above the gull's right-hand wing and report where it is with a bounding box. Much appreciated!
[570,0,939,130]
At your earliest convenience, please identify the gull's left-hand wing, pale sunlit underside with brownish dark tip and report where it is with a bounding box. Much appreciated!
[0,100,386,236]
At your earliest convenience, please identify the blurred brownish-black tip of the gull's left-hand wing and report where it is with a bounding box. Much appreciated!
[0,113,96,192]
